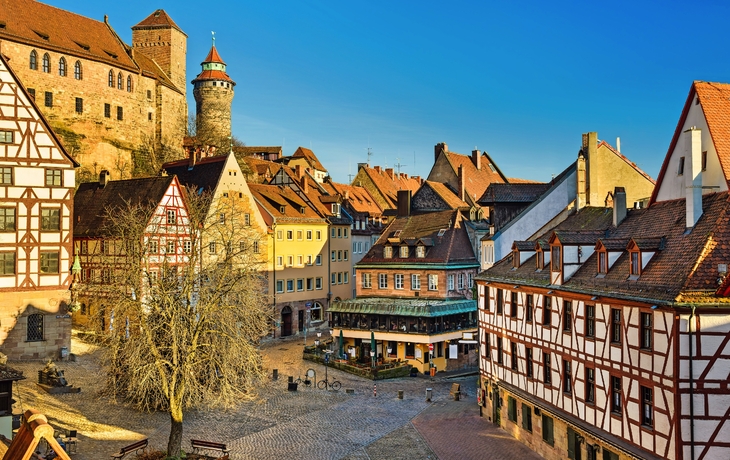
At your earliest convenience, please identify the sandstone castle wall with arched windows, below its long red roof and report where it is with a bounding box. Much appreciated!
[0,40,187,179]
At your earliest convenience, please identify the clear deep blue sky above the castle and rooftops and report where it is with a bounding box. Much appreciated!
[47,0,730,182]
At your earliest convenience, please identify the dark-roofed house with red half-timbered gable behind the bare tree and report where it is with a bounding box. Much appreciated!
[74,171,188,330]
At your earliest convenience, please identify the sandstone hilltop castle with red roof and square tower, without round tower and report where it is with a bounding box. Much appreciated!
[0,0,191,181]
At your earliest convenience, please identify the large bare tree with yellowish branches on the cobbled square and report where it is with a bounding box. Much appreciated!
[78,190,270,457]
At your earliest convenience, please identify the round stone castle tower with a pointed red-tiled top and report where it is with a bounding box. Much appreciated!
[192,43,236,148]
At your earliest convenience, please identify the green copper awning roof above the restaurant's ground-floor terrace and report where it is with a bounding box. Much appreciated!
[328,297,477,317]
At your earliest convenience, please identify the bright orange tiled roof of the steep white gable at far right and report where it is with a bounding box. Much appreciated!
[650,81,730,204]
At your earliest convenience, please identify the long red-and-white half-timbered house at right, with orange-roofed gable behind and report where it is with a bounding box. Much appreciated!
[477,82,730,460]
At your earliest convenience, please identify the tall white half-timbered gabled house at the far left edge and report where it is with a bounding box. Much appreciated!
[0,52,78,359]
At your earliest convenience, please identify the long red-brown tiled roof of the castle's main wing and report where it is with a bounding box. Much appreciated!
[0,0,137,72]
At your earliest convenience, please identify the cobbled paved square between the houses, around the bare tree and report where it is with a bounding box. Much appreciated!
[10,332,540,460]
